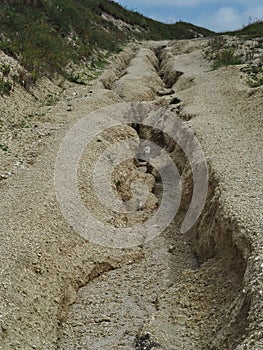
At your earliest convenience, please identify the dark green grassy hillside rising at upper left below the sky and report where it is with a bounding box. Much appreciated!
[0,0,214,79]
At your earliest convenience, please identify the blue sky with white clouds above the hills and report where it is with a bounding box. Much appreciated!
[115,0,263,31]
